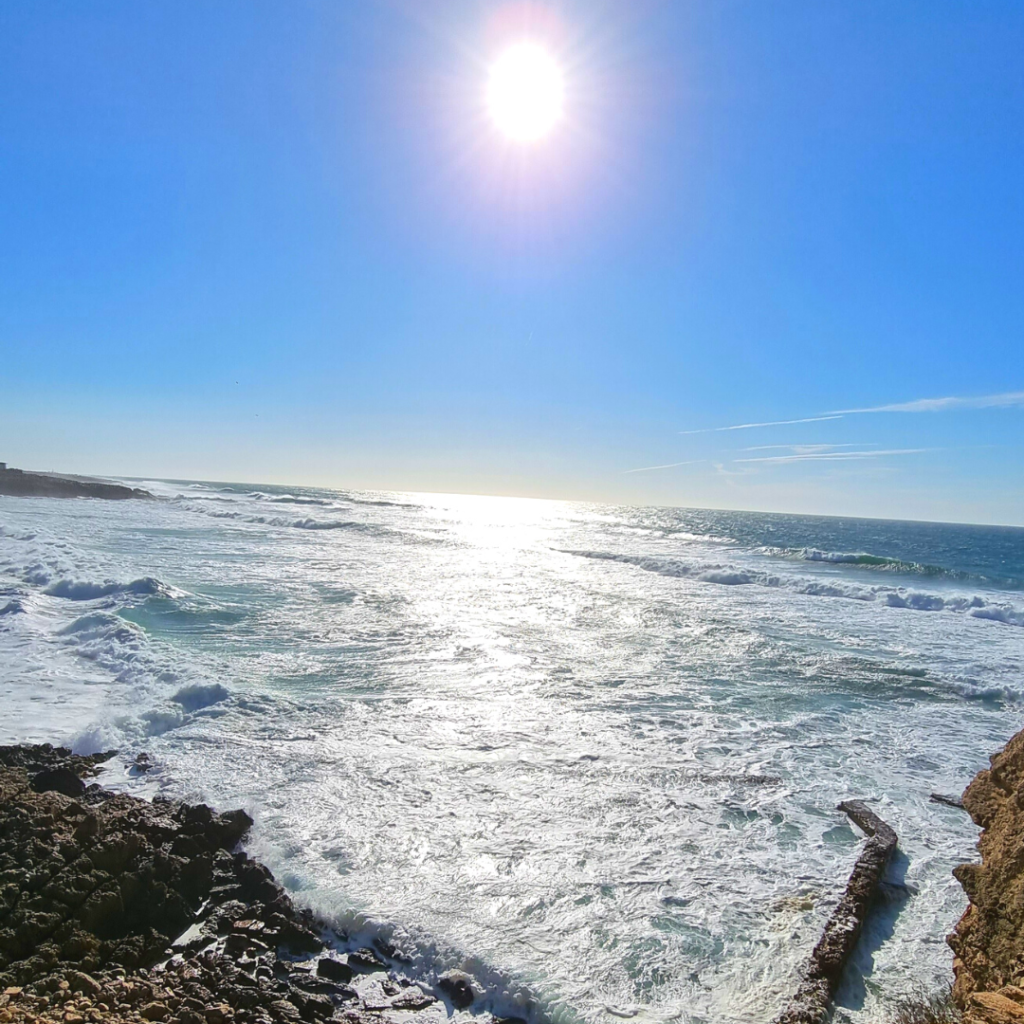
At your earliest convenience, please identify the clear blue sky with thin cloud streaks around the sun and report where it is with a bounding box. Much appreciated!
[0,0,1024,523]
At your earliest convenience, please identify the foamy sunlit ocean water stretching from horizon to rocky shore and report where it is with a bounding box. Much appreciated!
[0,481,1024,1024]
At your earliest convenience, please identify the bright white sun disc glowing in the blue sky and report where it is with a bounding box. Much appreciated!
[487,42,565,142]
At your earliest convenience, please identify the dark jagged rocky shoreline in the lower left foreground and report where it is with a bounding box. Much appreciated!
[0,744,516,1024]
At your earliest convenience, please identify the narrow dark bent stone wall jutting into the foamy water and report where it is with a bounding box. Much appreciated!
[775,800,896,1024]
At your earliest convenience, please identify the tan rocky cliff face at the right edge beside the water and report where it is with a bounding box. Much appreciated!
[948,731,1024,1024]
